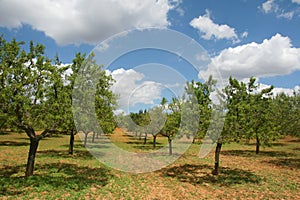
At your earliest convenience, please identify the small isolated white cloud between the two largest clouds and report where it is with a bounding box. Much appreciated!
[190,10,238,41]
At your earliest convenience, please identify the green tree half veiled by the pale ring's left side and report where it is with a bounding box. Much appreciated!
[72,54,116,146]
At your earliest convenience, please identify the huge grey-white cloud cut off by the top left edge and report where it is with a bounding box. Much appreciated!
[0,0,173,45]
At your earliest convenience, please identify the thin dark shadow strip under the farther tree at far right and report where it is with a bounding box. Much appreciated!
[221,150,294,157]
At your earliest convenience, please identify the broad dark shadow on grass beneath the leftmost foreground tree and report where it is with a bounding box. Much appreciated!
[0,163,112,196]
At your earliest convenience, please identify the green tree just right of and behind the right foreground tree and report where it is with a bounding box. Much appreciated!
[222,77,278,154]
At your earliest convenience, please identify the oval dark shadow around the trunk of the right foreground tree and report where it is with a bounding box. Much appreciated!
[162,164,262,186]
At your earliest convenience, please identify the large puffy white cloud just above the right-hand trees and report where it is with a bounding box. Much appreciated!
[199,34,300,82]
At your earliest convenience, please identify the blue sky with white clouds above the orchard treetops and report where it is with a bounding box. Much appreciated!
[0,0,300,112]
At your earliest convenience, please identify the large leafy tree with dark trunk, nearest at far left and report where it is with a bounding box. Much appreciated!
[0,37,61,176]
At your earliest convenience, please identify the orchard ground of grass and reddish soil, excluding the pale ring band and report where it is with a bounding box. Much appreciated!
[0,129,300,199]
